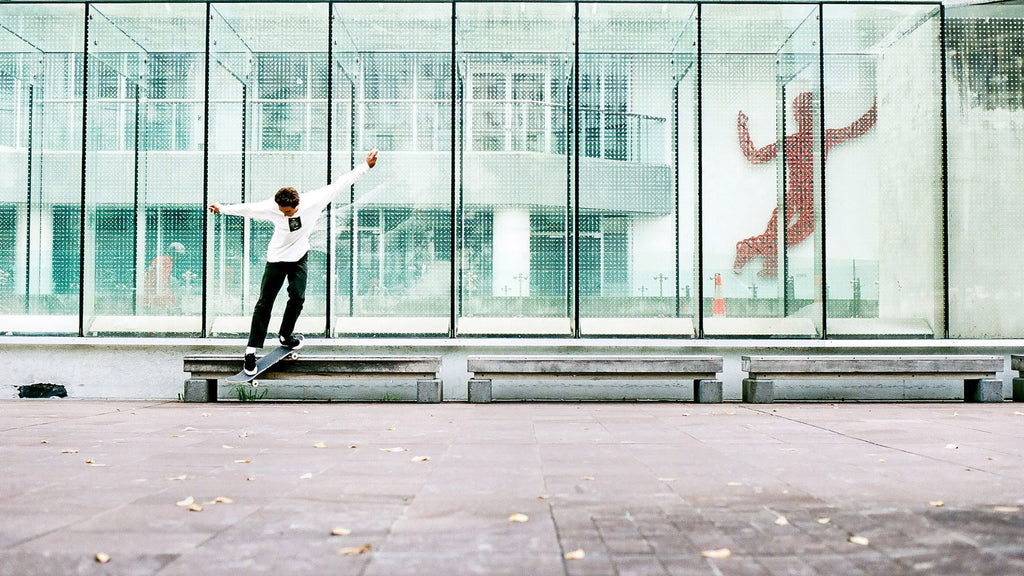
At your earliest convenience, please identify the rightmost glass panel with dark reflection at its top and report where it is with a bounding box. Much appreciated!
[945,2,1024,338]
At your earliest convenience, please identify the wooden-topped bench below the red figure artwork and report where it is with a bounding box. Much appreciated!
[742,355,1004,404]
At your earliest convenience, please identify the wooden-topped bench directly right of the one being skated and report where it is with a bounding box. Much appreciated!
[466,355,723,403]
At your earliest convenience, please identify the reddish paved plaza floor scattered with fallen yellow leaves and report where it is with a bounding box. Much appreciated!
[0,399,1024,576]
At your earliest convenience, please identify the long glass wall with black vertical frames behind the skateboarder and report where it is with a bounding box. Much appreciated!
[0,2,1024,338]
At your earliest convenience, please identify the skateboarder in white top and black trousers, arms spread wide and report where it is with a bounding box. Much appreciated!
[210,149,377,376]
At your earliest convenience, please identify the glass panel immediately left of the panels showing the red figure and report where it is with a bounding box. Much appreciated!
[579,3,696,337]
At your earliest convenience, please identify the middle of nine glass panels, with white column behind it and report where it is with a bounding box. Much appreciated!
[456,2,574,335]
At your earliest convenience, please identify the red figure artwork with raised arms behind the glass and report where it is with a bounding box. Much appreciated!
[732,92,878,278]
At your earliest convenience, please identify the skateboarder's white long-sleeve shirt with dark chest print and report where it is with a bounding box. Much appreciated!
[220,162,370,262]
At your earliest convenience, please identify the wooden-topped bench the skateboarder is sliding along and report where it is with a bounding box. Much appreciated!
[184,353,441,403]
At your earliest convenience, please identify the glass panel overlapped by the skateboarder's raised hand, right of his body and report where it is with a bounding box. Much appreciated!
[332,3,452,335]
